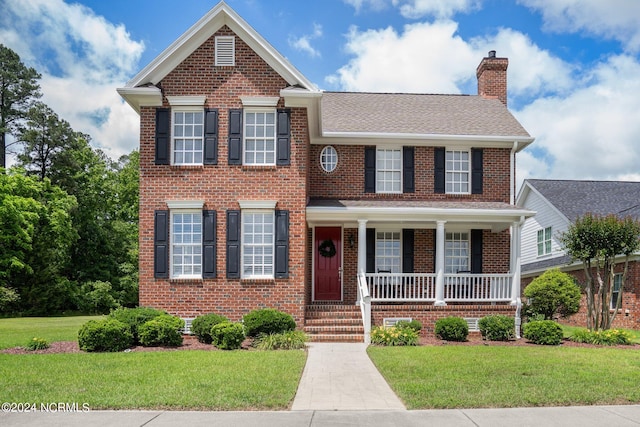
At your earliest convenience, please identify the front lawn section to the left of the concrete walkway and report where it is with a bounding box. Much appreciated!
[0,350,306,410]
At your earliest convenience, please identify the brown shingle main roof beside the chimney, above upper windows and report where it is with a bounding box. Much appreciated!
[322,92,530,138]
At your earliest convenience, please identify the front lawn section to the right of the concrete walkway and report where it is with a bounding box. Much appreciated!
[368,345,640,409]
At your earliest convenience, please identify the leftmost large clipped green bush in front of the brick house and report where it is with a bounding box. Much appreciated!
[78,318,133,352]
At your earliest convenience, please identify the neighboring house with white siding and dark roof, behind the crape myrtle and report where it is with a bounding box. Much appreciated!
[517,179,640,328]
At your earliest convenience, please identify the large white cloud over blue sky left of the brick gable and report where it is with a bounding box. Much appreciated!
[0,0,144,162]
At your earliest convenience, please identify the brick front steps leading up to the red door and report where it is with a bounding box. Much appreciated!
[304,304,364,342]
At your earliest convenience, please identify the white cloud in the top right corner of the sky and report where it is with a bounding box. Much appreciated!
[519,0,640,52]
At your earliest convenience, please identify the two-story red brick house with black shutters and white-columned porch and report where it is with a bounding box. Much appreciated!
[118,2,534,340]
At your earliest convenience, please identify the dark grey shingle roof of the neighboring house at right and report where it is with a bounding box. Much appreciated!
[527,179,640,222]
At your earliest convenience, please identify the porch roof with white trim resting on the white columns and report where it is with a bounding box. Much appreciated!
[306,199,535,232]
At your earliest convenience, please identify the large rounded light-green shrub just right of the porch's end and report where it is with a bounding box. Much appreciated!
[524,268,580,320]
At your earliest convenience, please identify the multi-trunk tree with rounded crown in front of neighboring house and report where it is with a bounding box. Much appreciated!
[560,214,640,331]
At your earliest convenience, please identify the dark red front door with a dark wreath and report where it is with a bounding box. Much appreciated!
[313,227,342,301]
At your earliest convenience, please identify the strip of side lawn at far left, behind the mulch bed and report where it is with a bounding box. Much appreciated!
[0,316,103,349]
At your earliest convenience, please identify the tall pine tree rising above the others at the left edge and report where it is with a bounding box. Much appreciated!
[0,44,41,168]
